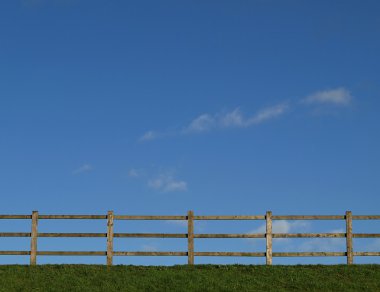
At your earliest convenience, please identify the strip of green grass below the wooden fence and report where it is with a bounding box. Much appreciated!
[0,265,380,292]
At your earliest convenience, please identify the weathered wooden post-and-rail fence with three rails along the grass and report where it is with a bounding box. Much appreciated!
[0,211,380,265]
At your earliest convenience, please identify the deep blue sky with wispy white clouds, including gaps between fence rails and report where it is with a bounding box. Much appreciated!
[0,0,380,264]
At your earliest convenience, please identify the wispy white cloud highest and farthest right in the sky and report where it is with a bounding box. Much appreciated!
[302,87,353,106]
